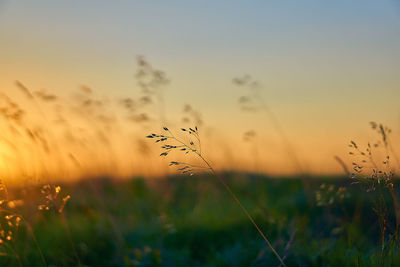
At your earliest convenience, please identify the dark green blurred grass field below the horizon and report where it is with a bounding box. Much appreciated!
[0,173,400,266]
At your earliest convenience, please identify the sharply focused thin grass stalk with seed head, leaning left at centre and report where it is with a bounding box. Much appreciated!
[147,127,286,266]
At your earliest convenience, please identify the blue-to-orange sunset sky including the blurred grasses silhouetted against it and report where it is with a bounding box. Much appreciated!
[0,0,400,182]
